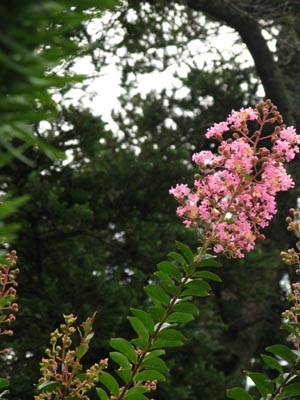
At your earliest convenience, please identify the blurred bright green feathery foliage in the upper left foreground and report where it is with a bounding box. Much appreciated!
[0,0,116,243]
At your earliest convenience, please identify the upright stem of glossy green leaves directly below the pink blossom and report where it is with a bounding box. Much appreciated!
[97,242,221,400]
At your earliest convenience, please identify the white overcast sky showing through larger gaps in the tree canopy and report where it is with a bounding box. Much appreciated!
[52,10,270,131]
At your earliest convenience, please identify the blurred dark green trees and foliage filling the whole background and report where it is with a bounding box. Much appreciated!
[0,0,300,400]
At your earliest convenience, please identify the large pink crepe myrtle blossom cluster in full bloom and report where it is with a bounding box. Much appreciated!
[169,100,300,258]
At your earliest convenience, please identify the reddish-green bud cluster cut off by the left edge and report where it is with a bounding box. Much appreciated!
[0,250,19,353]
